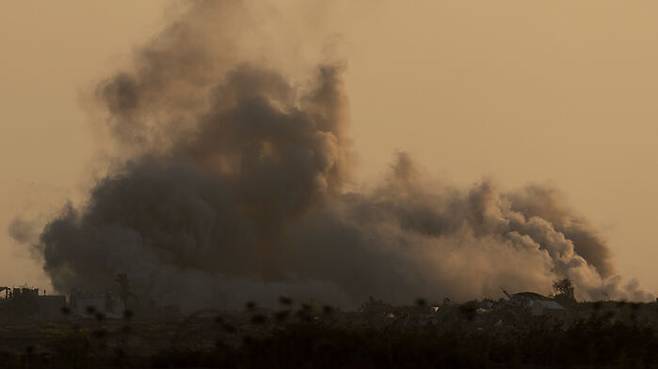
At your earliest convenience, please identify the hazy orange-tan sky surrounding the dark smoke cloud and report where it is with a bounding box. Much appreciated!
[0,0,658,293]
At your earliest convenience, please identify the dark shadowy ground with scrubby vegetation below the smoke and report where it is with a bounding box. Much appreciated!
[0,298,658,369]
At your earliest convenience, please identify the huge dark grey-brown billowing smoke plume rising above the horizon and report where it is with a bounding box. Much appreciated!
[20,1,651,306]
